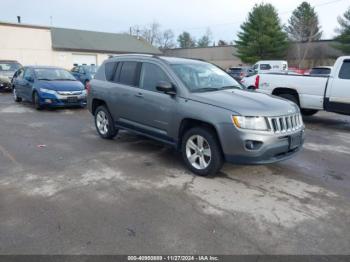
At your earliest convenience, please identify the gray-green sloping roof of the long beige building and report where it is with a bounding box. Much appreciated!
[51,28,161,54]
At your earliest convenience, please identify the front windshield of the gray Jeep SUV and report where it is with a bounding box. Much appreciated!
[171,63,242,92]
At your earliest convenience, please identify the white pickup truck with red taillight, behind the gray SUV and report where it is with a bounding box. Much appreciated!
[242,56,350,115]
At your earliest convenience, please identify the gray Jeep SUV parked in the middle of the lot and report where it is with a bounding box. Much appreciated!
[88,55,304,175]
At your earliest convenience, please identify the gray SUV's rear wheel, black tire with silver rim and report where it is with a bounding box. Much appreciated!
[95,106,118,139]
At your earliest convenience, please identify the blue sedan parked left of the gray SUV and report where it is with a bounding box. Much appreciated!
[13,66,86,109]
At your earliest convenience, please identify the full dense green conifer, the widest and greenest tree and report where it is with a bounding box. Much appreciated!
[235,4,288,63]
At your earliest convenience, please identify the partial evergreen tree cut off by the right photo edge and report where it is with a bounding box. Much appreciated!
[335,7,350,54]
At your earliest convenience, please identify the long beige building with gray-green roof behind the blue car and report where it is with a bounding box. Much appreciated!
[0,22,161,69]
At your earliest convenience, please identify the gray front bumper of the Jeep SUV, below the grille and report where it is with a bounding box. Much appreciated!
[220,123,305,164]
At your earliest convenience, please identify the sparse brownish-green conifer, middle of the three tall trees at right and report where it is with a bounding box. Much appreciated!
[286,2,322,42]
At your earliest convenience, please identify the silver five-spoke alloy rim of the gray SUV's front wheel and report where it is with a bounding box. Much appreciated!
[186,135,211,169]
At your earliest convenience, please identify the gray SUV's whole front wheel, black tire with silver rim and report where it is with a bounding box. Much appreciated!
[181,127,224,176]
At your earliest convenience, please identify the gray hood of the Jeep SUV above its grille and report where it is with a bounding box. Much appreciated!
[188,89,299,116]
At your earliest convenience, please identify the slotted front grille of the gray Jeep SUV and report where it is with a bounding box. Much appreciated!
[267,114,303,133]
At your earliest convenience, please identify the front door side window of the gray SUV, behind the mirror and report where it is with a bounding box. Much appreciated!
[140,63,170,92]
